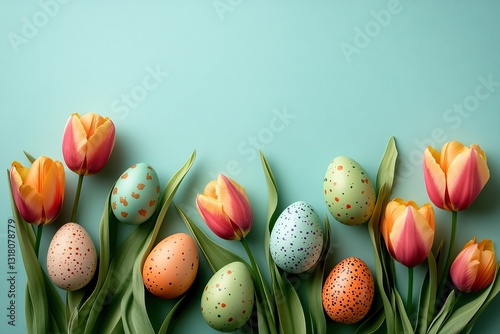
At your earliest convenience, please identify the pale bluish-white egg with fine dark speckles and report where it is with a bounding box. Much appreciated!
[269,201,323,273]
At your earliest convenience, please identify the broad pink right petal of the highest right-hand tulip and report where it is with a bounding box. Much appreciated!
[447,149,490,211]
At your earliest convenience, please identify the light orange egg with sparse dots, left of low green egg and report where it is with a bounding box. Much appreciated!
[142,233,198,299]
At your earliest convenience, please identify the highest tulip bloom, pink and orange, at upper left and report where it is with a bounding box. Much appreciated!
[62,113,115,175]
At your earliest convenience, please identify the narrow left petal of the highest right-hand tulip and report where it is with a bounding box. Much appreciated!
[424,146,448,210]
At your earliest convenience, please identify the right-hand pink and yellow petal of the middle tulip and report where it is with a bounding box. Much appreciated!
[216,174,253,235]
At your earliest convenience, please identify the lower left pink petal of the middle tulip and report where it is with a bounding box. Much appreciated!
[196,195,239,240]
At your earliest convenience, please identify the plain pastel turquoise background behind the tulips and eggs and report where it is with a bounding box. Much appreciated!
[0,0,500,333]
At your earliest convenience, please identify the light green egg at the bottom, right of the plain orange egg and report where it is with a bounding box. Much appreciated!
[201,262,255,332]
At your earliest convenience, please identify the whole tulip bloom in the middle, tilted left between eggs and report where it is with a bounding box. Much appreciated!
[196,174,253,240]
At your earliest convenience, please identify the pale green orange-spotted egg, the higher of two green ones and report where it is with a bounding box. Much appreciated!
[323,156,376,225]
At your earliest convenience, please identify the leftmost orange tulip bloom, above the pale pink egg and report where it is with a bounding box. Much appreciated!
[10,157,65,225]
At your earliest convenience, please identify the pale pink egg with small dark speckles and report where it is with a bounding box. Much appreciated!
[47,223,97,291]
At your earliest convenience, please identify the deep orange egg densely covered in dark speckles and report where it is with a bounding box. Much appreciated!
[322,257,375,324]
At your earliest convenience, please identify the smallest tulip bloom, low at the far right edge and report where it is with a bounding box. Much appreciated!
[450,237,497,293]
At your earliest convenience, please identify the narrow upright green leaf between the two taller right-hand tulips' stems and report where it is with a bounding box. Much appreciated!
[417,252,438,334]
